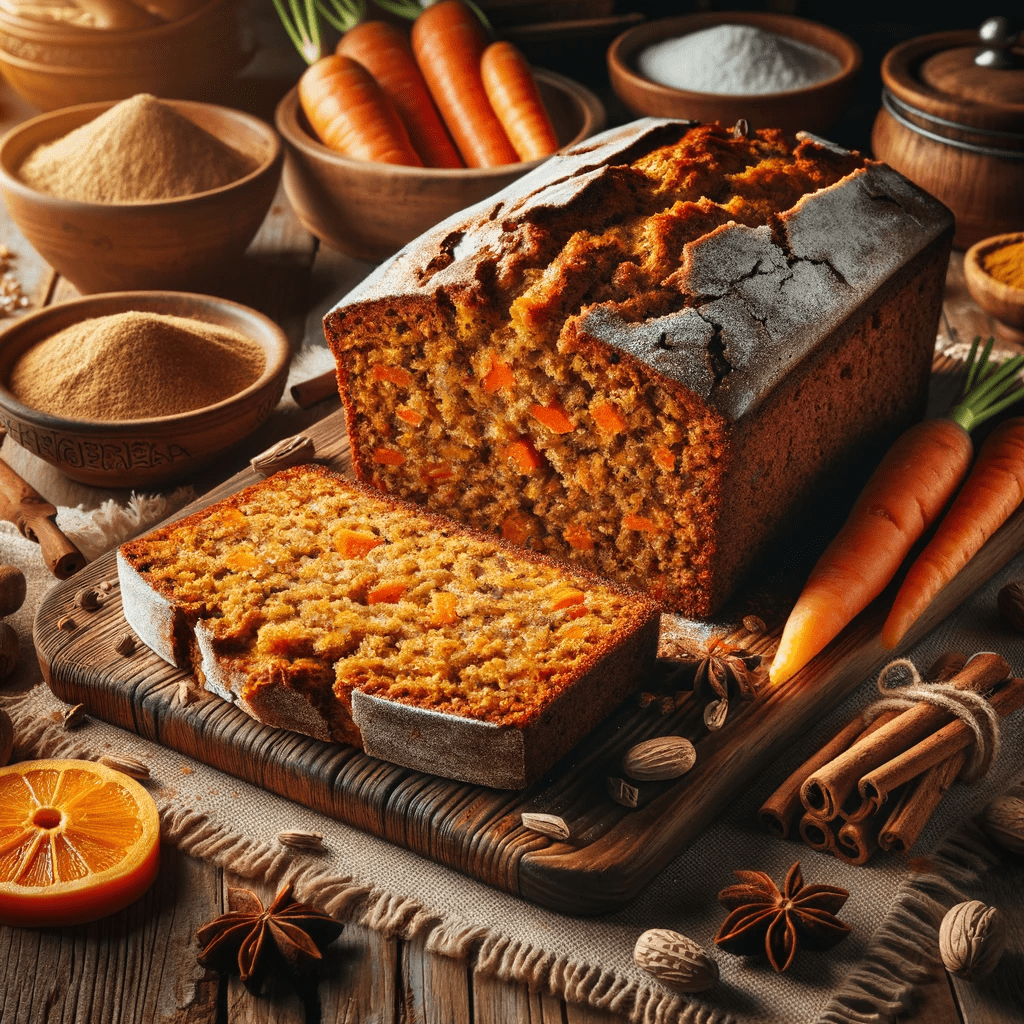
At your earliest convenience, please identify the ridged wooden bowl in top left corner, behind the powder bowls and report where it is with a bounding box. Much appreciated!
[0,0,252,111]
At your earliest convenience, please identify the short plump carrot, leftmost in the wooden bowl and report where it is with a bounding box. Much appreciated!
[299,53,423,167]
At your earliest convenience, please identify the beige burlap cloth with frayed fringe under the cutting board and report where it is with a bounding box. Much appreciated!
[0,344,1024,1024]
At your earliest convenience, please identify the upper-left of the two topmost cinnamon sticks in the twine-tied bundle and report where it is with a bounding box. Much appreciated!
[800,652,1010,821]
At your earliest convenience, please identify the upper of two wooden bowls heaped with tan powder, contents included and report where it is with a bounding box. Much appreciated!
[0,93,283,294]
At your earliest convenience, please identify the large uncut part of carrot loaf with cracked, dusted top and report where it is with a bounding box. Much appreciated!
[325,119,953,616]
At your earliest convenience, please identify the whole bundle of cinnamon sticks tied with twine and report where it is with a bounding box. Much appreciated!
[759,652,1024,864]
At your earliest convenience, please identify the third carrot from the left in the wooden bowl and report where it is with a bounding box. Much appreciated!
[413,0,519,167]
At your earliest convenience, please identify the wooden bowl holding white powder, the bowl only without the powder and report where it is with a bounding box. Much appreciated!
[608,11,861,134]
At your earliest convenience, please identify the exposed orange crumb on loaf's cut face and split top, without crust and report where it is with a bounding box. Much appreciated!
[328,125,863,614]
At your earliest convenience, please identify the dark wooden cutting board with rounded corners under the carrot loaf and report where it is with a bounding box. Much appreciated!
[35,395,1024,914]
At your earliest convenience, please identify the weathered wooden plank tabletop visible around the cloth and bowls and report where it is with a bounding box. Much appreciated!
[0,59,1024,1024]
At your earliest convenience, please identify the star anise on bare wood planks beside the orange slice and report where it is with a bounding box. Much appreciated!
[196,885,343,992]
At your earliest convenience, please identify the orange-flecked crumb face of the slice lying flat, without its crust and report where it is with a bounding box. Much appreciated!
[121,466,657,743]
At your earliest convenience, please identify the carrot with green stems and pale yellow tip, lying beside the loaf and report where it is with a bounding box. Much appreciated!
[769,341,1024,683]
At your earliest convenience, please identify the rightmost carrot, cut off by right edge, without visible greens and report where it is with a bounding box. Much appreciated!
[882,416,1024,649]
